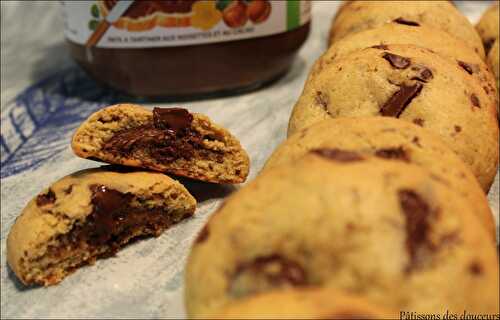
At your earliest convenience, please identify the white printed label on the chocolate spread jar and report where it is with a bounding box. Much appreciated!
[61,0,311,48]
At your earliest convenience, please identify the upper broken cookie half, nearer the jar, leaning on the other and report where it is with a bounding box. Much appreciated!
[71,104,249,183]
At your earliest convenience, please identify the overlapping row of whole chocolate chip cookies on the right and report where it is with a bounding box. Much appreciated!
[186,1,499,319]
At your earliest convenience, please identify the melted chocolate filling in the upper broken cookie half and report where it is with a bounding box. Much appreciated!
[103,108,203,162]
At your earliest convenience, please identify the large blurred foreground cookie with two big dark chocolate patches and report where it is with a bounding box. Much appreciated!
[185,154,499,317]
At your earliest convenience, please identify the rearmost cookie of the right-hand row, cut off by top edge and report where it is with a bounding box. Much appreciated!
[330,0,485,59]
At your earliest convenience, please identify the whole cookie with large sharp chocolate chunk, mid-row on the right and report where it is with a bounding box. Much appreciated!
[288,45,498,190]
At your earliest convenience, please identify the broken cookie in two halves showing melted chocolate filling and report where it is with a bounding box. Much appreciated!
[7,104,249,286]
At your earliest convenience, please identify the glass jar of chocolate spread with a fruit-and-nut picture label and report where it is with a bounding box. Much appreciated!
[62,0,311,98]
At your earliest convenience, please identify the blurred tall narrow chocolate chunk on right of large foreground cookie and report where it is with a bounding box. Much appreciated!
[398,189,431,271]
